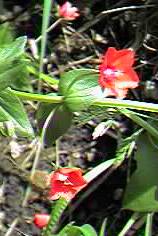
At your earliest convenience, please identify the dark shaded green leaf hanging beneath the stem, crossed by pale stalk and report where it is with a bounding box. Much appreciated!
[37,103,73,147]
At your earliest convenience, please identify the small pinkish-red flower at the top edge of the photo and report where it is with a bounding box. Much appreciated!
[59,1,80,20]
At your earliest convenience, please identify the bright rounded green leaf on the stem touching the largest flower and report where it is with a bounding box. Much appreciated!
[59,69,102,111]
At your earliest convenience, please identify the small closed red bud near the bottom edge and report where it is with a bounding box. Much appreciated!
[33,214,50,229]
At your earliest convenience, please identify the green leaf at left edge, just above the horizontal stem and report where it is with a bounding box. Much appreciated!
[0,37,31,91]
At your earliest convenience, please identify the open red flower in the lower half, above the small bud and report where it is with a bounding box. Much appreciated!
[49,168,87,201]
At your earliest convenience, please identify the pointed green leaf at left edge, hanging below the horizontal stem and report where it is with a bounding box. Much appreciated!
[0,89,33,136]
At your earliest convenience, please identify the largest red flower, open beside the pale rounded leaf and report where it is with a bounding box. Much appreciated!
[99,47,139,98]
